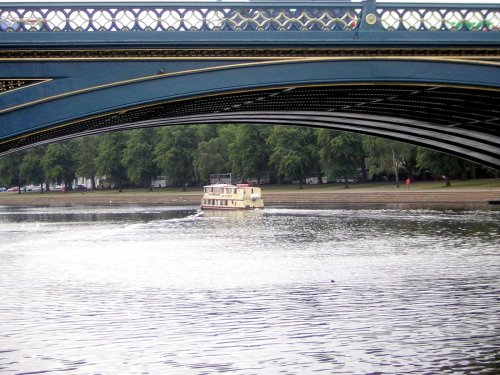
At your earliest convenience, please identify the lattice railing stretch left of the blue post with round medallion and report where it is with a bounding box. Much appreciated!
[0,4,361,32]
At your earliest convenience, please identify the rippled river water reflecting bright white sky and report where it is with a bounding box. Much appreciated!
[0,207,500,374]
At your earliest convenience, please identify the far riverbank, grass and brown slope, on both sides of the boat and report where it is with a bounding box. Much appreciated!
[0,179,500,207]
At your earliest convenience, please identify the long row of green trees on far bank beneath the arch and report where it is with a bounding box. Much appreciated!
[0,124,492,190]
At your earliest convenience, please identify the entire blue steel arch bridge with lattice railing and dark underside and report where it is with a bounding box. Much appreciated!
[0,0,500,169]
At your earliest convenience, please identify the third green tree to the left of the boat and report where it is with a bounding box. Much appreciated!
[96,131,128,192]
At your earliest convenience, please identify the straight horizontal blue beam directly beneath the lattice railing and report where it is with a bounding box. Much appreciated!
[0,28,499,49]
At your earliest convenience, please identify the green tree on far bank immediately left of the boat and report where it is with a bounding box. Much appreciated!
[154,125,198,190]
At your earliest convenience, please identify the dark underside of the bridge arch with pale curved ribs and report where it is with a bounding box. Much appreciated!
[0,83,500,168]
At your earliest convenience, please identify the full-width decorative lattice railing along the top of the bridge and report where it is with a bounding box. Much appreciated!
[0,0,500,33]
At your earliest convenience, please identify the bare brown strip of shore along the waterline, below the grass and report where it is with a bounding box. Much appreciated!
[0,188,500,208]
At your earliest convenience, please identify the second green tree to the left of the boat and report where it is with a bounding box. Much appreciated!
[123,129,158,191]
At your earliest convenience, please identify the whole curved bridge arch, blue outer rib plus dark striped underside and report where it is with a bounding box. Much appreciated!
[0,57,500,167]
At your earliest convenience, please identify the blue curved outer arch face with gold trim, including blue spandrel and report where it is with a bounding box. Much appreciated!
[0,58,500,128]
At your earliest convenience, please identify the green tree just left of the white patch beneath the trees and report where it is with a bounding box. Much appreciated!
[41,141,76,189]
